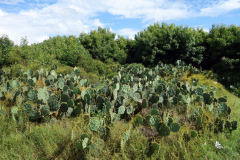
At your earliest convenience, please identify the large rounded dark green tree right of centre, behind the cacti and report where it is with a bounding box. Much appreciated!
[135,23,207,66]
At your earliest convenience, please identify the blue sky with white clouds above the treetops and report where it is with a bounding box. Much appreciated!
[0,0,240,44]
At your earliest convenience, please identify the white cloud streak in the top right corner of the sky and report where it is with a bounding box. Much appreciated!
[200,0,240,17]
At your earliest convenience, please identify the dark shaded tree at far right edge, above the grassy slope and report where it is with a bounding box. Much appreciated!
[202,24,240,96]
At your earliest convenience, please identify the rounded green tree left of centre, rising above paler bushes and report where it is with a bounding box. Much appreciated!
[79,27,127,64]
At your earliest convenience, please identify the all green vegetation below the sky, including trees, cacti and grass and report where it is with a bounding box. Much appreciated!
[0,23,240,159]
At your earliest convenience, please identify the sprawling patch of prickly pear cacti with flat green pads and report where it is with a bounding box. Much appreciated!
[0,61,237,156]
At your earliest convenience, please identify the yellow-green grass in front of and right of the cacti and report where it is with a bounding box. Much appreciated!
[0,71,240,159]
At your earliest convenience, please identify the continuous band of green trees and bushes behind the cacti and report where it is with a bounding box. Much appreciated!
[0,23,240,94]
